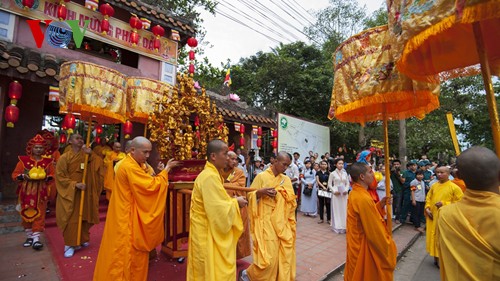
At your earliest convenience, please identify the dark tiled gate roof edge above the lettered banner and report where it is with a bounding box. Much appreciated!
[106,0,196,40]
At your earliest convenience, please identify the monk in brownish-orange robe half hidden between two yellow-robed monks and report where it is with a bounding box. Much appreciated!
[219,151,252,259]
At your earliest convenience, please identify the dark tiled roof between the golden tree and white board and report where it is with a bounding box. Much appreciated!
[207,91,276,128]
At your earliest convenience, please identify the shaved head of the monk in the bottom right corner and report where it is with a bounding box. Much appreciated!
[457,146,500,190]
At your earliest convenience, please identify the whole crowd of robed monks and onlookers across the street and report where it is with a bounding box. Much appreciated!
[12,132,500,281]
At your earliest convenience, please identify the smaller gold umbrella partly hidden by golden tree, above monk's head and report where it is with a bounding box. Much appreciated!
[127,77,173,137]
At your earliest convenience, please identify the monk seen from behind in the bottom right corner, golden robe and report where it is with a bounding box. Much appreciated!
[436,146,500,281]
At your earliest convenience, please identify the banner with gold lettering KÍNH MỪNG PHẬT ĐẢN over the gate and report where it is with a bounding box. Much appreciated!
[0,0,177,64]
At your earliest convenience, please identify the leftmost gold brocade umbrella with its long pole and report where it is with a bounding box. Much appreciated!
[59,61,126,245]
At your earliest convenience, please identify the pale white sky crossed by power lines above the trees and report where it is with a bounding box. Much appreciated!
[197,0,385,67]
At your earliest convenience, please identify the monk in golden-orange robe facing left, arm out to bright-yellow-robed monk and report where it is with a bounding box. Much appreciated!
[240,151,297,281]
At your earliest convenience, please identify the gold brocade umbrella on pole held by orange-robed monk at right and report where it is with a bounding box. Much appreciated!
[328,26,439,233]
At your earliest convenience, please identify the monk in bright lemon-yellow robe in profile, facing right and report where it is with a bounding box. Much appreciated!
[186,140,247,281]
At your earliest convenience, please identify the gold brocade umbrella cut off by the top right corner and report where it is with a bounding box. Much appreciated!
[387,0,500,157]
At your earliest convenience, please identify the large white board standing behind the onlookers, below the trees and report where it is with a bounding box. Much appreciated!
[278,113,330,160]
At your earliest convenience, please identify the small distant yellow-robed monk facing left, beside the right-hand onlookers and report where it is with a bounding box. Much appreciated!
[425,166,464,267]
